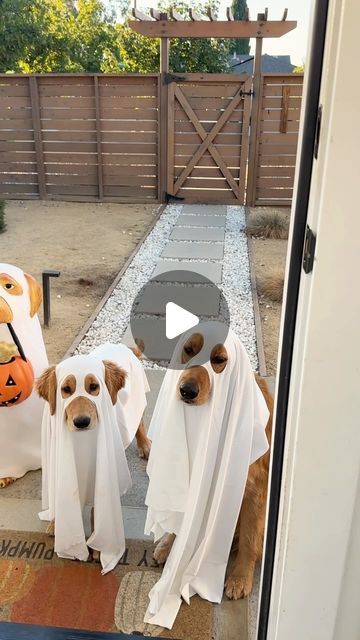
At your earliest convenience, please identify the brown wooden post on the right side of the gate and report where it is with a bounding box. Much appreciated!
[246,31,263,206]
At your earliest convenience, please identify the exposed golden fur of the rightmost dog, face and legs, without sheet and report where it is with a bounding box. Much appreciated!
[154,333,273,600]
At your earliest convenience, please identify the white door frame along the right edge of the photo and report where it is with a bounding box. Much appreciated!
[258,0,360,640]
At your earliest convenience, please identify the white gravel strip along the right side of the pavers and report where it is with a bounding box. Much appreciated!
[219,205,259,370]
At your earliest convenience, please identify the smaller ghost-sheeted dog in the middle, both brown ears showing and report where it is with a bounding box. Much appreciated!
[37,344,149,574]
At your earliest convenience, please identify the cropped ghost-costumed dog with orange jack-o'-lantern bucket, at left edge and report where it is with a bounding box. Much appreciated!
[0,263,48,487]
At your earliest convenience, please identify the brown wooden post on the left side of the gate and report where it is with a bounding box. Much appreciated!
[159,31,169,202]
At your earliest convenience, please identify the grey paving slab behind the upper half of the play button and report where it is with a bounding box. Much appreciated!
[136,283,220,316]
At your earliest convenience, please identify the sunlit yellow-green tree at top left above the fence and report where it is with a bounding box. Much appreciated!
[0,0,121,73]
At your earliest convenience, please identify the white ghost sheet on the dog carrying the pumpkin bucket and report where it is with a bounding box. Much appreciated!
[0,263,48,478]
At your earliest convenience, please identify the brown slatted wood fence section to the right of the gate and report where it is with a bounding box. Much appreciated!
[247,73,303,206]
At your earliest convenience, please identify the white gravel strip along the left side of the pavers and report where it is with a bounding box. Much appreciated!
[76,204,183,353]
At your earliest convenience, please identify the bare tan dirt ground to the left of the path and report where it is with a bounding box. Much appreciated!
[0,200,159,364]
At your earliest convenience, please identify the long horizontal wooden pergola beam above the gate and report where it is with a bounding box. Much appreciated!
[129,17,297,38]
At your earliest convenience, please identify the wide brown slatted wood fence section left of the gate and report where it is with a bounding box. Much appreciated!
[0,74,159,202]
